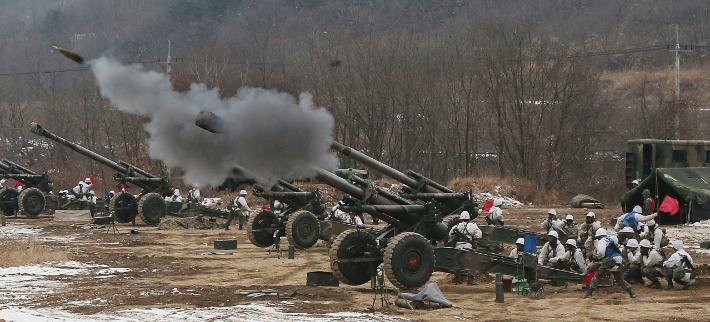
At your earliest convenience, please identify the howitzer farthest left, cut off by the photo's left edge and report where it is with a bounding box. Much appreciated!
[0,160,53,218]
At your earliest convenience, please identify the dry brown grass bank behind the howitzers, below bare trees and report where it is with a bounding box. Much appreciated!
[448,176,560,205]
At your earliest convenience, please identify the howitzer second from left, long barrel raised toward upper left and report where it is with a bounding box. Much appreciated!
[30,123,172,225]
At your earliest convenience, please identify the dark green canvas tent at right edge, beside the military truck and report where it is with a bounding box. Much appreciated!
[621,168,710,225]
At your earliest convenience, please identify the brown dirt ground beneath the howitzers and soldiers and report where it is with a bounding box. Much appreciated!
[0,206,710,321]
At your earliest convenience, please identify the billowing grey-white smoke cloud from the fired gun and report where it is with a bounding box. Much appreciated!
[91,58,338,187]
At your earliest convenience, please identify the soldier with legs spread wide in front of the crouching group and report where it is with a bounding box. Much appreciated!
[584,228,636,299]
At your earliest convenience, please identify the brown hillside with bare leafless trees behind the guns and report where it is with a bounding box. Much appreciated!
[0,0,710,201]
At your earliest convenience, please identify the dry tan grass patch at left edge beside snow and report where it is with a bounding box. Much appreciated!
[0,239,68,267]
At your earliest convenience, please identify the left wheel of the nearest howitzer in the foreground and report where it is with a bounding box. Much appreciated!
[328,229,381,285]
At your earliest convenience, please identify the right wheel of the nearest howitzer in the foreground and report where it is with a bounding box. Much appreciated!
[384,232,436,289]
